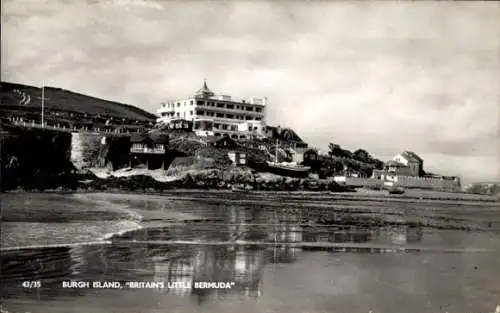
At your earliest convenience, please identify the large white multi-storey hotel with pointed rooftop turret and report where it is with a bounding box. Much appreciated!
[157,82,267,139]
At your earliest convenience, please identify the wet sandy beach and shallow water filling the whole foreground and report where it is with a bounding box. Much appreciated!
[0,191,500,313]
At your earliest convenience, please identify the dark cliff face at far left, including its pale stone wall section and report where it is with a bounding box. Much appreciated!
[0,127,136,190]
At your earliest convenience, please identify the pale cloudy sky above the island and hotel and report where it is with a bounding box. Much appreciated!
[1,0,500,182]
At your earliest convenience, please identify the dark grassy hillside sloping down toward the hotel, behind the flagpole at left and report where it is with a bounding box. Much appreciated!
[0,82,156,122]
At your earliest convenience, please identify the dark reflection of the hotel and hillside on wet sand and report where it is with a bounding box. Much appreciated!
[2,202,430,303]
